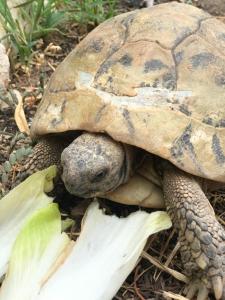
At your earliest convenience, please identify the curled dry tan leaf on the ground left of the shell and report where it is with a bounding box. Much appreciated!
[13,90,30,135]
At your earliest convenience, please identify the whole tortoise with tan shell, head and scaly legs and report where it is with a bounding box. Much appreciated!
[22,2,225,300]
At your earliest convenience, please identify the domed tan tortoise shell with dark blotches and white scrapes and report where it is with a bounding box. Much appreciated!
[31,2,225,182]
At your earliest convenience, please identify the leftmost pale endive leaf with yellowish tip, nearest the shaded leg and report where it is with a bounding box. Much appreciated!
[0,167,56,278]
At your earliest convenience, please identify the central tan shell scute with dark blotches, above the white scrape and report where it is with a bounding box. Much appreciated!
[94,41,173,96]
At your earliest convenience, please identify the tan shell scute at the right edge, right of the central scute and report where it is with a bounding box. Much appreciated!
[175,34,225,127]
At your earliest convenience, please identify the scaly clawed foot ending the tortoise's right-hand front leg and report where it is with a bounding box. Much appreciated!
[180,215,225,300]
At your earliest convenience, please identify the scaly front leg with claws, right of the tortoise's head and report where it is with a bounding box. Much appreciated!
[163,166,225,300]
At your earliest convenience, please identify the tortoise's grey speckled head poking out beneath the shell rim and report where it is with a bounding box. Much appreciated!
[61,133,137,198]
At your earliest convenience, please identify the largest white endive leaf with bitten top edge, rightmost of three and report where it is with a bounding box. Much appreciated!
[37,202,171,300]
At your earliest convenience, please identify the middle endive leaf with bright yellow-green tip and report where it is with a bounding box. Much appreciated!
[0,203,72,300]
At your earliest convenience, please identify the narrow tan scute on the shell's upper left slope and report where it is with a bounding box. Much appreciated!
[48,12,135,93]
